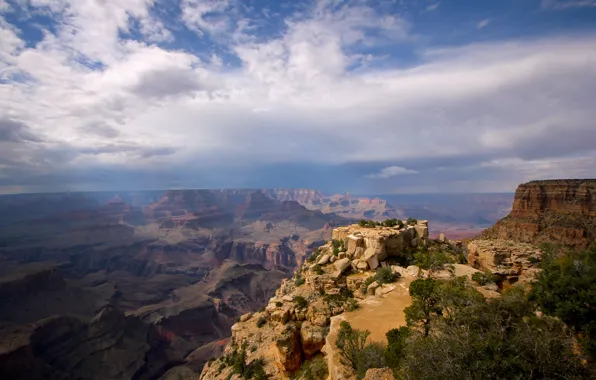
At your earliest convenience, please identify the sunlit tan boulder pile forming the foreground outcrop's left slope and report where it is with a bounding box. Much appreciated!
[200,221,428,379]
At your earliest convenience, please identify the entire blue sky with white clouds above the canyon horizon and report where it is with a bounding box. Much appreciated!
[0,0,596,194]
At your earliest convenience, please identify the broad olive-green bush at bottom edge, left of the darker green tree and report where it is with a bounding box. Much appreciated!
[396,286,591,380]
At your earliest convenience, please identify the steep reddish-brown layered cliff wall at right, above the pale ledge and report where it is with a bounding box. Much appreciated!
[479,179,596,248]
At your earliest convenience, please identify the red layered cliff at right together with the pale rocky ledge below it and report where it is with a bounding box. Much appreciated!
[467,180,596,286]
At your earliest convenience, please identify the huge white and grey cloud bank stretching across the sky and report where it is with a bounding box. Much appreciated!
[0,0,596,190]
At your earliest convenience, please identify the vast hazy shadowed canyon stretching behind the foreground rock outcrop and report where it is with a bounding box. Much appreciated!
[0,189,520,379]
